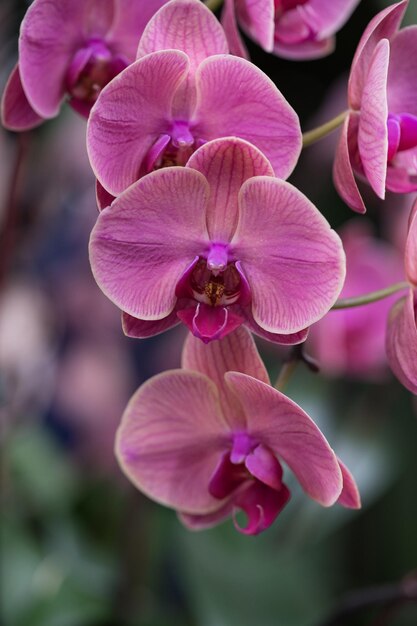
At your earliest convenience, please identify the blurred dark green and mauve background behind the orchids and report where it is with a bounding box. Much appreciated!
[0,0,417,626]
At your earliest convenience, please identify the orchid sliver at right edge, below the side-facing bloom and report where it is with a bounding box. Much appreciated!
[386,202,417,394]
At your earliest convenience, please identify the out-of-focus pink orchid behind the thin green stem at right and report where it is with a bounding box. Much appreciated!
[309,218,403,380]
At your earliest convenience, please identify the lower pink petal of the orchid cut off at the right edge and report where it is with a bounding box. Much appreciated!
[386,289,417,395]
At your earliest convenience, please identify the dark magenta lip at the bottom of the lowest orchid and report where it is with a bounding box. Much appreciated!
[233,481,290,535]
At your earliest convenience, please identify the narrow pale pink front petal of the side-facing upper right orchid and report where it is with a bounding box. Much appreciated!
[358,39,390,199]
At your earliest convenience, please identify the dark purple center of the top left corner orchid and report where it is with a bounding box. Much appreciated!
[66,38,129,109]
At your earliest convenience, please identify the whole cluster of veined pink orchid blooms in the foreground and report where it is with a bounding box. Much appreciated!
[2,0,417,534]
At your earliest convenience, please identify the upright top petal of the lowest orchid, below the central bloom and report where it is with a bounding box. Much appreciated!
[181,326,269,429]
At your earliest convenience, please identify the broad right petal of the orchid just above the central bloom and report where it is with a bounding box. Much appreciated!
[194,56,301,178]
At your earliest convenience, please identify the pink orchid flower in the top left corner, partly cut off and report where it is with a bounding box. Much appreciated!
[2,0,167,131]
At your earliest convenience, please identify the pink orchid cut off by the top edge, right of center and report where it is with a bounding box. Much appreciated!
[222,0,360,60]
